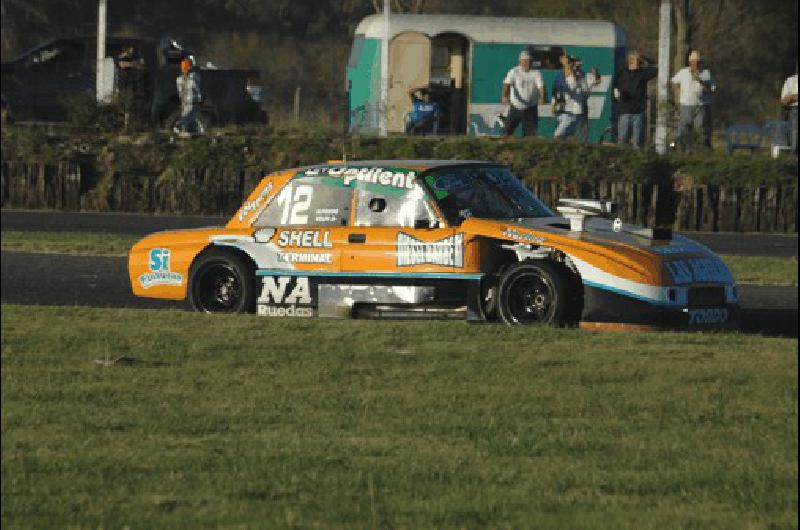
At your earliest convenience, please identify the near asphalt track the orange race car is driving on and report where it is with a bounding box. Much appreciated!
[0,252,797,337]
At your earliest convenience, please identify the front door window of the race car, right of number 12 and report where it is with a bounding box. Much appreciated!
[355,182,438,228]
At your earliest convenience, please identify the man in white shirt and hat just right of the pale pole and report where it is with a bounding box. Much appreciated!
[669,50,717,149]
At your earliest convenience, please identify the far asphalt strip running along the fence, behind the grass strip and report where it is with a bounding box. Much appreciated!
[0,210,797,257]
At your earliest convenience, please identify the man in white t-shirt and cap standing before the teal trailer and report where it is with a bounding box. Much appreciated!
[500,50,545,136]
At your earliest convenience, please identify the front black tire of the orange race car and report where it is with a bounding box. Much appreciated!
[497,261,583,326]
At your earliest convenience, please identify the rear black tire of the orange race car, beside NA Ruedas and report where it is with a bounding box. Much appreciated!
[189,249,256,313]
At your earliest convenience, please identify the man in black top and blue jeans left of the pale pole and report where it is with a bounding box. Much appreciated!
[614,51,658,149]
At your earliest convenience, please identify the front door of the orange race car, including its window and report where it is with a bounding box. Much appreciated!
[341,182,464,278]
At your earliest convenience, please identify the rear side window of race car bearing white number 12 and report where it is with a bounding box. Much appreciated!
[253,177,352,227]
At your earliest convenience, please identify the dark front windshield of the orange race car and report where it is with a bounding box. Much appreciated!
[424,166,553,224]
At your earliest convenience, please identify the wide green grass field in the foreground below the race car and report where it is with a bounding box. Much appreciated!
[2,305,798,529]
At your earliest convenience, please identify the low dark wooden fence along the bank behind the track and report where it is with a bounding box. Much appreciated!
[0,161,798,233]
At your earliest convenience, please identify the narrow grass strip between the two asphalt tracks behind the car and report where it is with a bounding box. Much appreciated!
[0,230,797,286]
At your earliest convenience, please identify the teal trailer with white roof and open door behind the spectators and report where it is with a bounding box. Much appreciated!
[347,15,625,141]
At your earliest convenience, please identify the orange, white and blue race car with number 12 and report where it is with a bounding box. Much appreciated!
[128,160,738,329]
